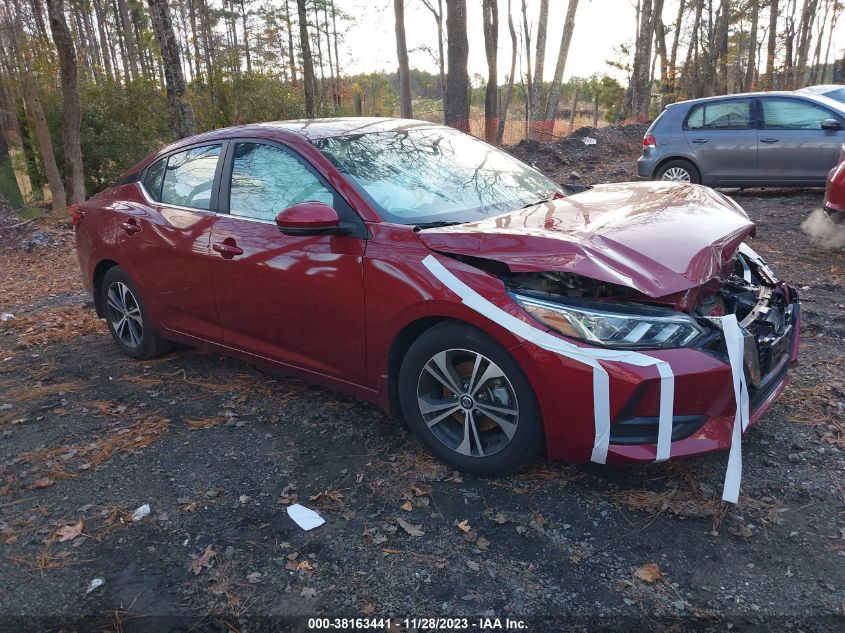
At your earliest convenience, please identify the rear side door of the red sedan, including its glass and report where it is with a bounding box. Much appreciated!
[120,143,224,342]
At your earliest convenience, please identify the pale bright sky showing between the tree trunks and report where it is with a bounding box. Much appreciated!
[338,0,845,83]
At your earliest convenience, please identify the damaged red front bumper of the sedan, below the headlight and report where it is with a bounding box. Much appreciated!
[511,286,800,463]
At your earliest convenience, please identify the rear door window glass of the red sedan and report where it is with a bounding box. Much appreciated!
[161,145,221,210]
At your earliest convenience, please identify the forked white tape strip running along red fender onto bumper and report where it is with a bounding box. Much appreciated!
[422,255,675,464]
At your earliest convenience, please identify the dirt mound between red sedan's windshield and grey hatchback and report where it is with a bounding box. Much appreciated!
[505,123,648,183]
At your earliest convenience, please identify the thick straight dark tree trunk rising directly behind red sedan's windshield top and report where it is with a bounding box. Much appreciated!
[443,0,469,132]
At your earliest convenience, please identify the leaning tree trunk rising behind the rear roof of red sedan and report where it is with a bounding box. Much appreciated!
[148,0,197,138]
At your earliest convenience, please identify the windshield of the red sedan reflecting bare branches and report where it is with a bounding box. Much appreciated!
[314,127,559,225]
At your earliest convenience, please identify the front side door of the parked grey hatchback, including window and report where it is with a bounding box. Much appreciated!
[757,96,845,185]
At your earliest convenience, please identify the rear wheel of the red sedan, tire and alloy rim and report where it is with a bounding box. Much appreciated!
[100,266,172,360]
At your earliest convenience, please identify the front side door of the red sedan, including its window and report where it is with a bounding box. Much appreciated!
[211,141,366,384]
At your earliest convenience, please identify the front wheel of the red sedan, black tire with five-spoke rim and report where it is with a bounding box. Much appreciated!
[399,321,543,475]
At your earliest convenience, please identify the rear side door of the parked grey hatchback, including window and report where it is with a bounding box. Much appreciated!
[683,98,757,184]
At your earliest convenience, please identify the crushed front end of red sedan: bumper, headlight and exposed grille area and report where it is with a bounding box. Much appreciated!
[503,245,800,463]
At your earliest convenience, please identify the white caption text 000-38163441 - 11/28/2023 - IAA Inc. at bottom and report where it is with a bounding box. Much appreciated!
[308,617,528,631]
